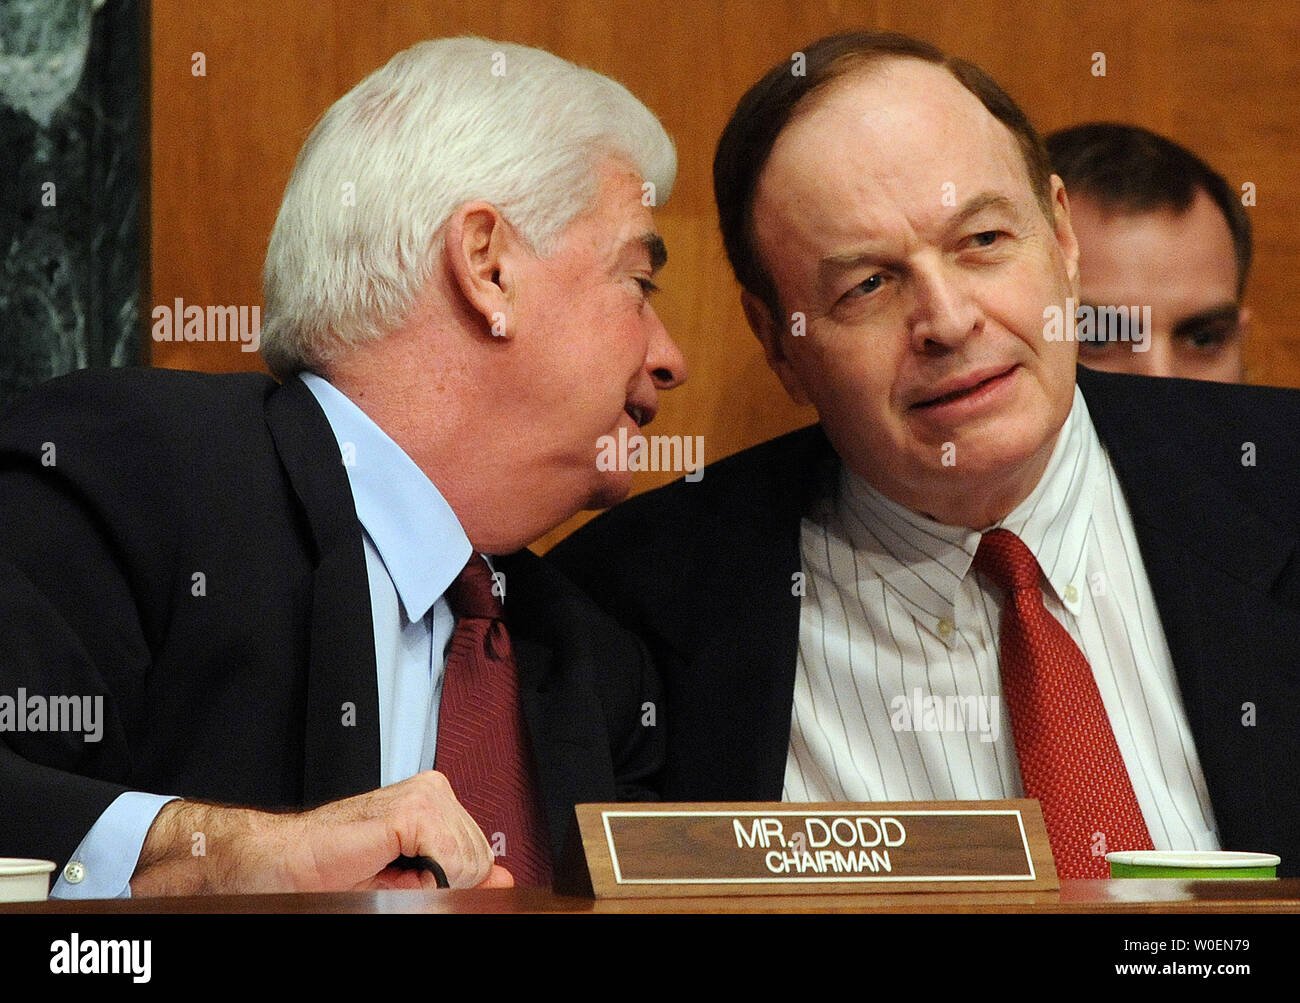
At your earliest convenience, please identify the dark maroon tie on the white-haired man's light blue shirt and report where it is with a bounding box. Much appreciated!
[434,553,551,885]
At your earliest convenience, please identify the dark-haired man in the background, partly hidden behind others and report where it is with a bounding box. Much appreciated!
[1047,122,1251,383]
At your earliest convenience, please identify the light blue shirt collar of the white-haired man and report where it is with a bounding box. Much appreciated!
[299,373,473,622]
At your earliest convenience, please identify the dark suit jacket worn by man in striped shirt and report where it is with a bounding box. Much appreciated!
[547,369,1300,874]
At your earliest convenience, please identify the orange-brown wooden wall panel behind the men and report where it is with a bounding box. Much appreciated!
[151,0,1300,548]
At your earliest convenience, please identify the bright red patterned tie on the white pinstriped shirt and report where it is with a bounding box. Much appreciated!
[972,529,1152,878]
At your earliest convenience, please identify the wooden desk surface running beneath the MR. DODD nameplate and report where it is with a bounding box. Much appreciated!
[0,878,1300,915]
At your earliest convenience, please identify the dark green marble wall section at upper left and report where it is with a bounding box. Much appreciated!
[0,0,144,409]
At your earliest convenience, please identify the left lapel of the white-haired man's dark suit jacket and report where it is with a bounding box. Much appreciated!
[267,379,380,806]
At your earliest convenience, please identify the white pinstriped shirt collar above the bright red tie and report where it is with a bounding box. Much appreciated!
[836,387,1105,644]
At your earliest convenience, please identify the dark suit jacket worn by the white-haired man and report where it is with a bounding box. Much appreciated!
[0,369,663,861]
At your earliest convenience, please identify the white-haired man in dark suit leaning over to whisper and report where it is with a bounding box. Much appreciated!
[0,39,684,898]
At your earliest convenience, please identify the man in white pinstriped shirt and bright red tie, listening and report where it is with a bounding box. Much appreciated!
[549,35,1300,877]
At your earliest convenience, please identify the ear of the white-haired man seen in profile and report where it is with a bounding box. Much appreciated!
[443,201,514,338]
